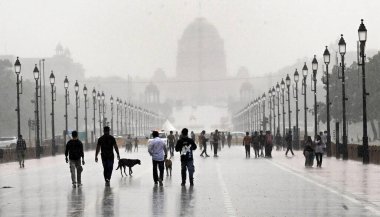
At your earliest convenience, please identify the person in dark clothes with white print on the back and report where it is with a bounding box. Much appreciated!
[175,128,197,186]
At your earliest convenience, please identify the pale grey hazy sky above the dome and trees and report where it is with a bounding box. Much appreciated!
[0,0,380,77]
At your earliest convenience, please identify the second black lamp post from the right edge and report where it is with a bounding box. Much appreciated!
[338,34,348,160]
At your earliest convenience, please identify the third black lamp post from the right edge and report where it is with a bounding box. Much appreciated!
[323,46,331,157]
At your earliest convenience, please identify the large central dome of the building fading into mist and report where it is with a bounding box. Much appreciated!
[176,18,227,104]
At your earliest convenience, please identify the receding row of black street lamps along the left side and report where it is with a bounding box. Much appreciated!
[14,61,164,158]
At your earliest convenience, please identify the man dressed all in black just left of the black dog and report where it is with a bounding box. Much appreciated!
[95,126,120,186]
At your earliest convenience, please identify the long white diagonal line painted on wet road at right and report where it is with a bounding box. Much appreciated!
[268,160,380,216]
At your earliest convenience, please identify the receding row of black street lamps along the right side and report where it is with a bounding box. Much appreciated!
[233,20,369,164]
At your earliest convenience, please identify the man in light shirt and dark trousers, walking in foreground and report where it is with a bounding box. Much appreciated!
[148,131,168,186]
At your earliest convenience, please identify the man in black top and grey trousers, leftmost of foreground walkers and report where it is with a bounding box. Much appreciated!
[65,131,84,188]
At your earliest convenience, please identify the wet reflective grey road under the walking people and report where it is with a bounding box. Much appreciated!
[0,147,380,217]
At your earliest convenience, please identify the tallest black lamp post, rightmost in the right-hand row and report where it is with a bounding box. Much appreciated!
[358,19,369,164]
